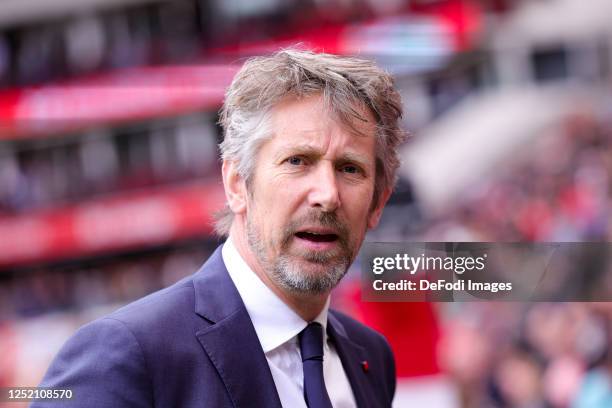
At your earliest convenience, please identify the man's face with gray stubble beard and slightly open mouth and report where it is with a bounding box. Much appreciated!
[246,96,382,293]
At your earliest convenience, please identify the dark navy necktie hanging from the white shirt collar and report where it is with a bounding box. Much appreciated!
[298,323,332,408]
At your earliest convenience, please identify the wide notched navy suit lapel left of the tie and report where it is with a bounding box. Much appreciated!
[194,247,281,408]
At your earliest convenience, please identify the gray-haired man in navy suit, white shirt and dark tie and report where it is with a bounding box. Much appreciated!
[34,50,403,408]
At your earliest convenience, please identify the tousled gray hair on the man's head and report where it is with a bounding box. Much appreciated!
[215,49,405,236]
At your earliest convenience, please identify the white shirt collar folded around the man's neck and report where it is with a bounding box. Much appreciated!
[221,237,330,353]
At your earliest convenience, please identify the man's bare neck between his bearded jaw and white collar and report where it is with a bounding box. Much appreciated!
[229,220,329,322]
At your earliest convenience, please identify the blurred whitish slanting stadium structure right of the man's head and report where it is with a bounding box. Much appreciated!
[400,86,580,215]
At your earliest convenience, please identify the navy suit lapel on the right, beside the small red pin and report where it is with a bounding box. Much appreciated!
[327,313,372,408]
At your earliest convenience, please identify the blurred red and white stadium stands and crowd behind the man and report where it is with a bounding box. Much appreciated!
[0,0,612,408]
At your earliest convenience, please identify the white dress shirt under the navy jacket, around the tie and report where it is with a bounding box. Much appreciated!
[221,238,357,408]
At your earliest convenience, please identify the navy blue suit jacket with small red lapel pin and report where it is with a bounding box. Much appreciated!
[32,248,395,408]
